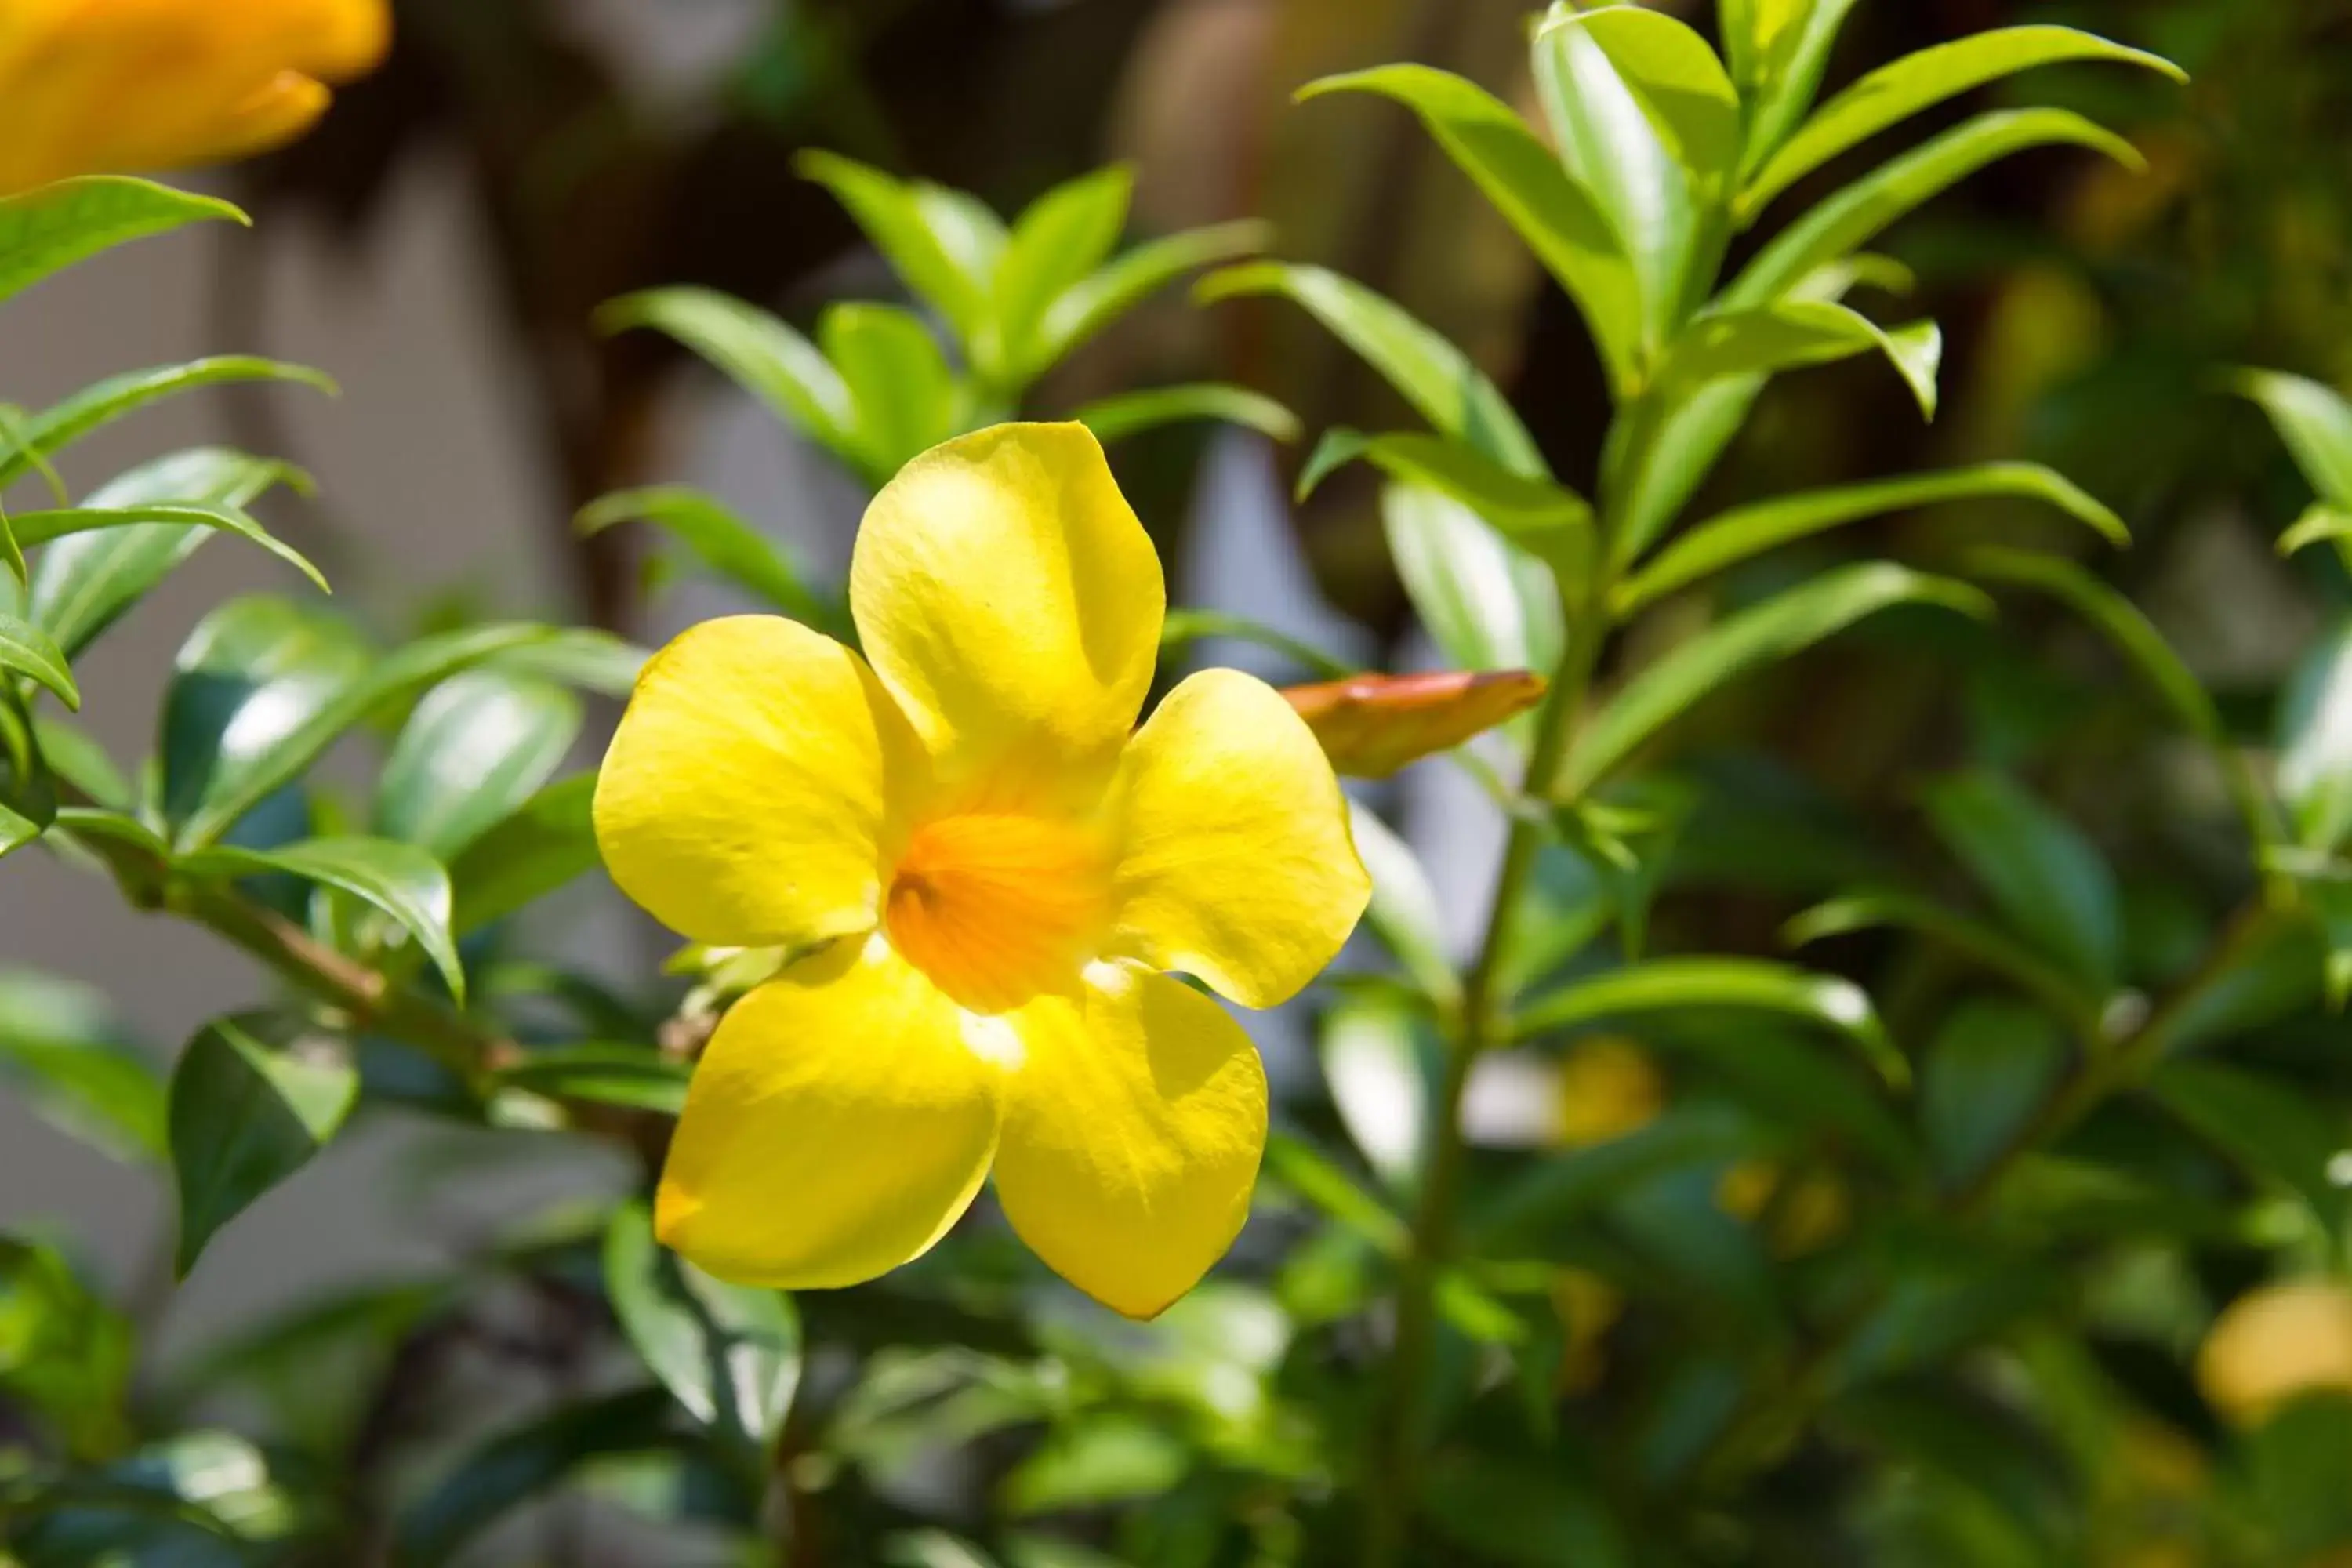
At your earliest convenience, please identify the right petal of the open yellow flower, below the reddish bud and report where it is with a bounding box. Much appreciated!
[1112,670,1371,1006]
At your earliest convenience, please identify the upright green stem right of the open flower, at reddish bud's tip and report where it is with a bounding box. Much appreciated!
[1364,587,1609,1568]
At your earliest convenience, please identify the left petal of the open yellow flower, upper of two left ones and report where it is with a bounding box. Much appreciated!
[595,616,922,947]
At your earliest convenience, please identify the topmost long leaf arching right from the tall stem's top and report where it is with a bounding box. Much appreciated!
[1738,26,2187,219]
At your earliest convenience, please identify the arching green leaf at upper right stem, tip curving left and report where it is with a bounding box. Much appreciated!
[1298,66,1644,392]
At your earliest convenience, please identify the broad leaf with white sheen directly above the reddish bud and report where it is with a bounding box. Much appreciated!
[1381,482,1566,670]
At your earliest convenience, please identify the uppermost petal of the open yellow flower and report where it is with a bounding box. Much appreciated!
[849,426,1167,808]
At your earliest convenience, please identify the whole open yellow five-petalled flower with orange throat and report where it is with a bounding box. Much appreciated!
[595,426,1371,1316]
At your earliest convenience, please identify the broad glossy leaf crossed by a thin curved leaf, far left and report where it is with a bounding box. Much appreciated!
[26,447,308,659]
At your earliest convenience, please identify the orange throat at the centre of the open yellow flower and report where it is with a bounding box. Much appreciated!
[882,815,1110,1013]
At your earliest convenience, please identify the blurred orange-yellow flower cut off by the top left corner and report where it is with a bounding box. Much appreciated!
[0,0,390,195]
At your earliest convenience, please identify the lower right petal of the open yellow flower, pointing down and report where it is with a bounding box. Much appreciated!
[997,964,1265,1319]
